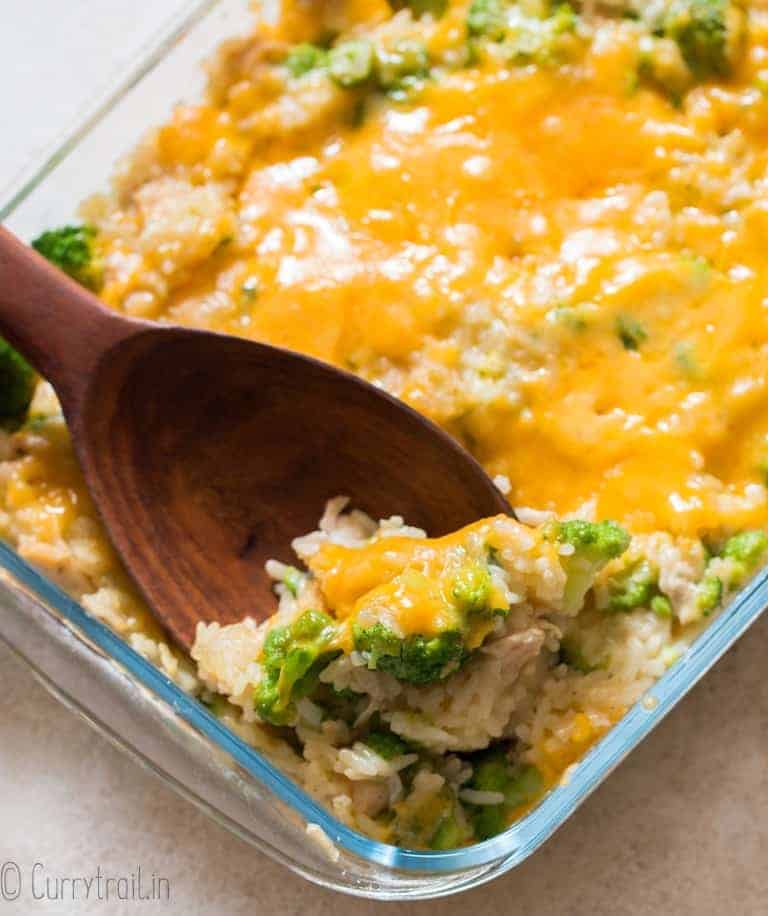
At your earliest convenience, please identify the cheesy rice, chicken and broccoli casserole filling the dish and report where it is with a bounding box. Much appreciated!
[0,0,768,849]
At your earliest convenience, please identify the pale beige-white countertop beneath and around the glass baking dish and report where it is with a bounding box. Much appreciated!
[0,0,768,916]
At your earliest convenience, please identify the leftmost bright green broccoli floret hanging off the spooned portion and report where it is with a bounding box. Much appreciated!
[255,610,339,725]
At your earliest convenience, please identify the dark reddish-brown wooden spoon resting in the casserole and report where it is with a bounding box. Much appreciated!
[0,228,509,648]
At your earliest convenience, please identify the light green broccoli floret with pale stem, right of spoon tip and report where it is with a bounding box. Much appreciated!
[547,519,630,613]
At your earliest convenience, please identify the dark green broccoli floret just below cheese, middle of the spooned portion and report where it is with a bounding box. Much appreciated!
[352,623,466,684]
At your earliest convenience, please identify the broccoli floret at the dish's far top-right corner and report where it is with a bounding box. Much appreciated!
[661,0,744,79]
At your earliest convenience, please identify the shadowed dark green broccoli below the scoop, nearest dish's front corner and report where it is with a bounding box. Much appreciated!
[467,747,544,840]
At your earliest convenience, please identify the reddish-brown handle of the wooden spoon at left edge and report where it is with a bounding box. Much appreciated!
[0,226,136,408]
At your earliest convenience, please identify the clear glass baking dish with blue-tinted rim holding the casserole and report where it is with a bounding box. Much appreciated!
[0,0,768,900]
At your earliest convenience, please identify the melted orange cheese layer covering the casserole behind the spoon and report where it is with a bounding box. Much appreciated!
[97,0,768,544]
